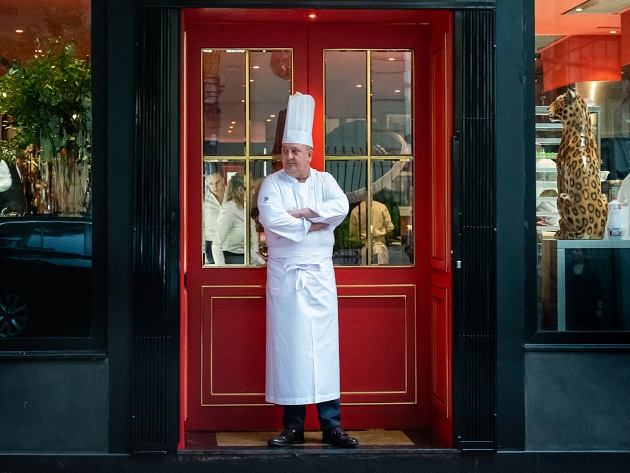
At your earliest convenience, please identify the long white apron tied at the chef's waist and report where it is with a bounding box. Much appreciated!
[265,249,339,404]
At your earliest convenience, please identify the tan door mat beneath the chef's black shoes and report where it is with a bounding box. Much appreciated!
[217,429,414,447]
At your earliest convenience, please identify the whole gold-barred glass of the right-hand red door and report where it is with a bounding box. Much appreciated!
[324,50,414,266]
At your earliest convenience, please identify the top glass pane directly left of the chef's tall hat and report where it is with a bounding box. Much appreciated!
[249,50,292,155]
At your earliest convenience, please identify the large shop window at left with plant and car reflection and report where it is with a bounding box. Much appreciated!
[0,0,92,338]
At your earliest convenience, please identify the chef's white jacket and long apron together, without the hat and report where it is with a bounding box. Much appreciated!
[258,169,348,405]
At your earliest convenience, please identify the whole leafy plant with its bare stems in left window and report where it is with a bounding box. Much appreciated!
[0,39,91,215]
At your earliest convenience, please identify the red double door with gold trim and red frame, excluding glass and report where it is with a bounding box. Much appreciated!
[182,10,452,441]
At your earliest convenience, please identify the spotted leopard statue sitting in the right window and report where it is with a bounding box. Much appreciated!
[547,89,608,240]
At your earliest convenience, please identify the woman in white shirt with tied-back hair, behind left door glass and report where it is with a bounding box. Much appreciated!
[212,172,264,265]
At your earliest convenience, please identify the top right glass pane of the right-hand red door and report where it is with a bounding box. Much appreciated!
[370,51,412,155]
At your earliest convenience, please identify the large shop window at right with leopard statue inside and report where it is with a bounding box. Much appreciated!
[532,0,630,332]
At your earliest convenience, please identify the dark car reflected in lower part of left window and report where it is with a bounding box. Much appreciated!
[0,217,92,338]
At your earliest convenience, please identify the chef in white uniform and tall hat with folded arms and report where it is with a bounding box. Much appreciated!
[258,92,358,447]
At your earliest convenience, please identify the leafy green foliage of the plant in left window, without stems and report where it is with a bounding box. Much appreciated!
[0,40,91,161]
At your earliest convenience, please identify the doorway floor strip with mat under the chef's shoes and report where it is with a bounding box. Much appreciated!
[179,429,456,455]
